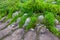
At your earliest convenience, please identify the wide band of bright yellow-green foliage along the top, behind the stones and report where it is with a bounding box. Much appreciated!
[20,0,60,14]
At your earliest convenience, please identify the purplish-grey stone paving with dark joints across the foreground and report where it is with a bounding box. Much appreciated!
[0,20,60,40]
